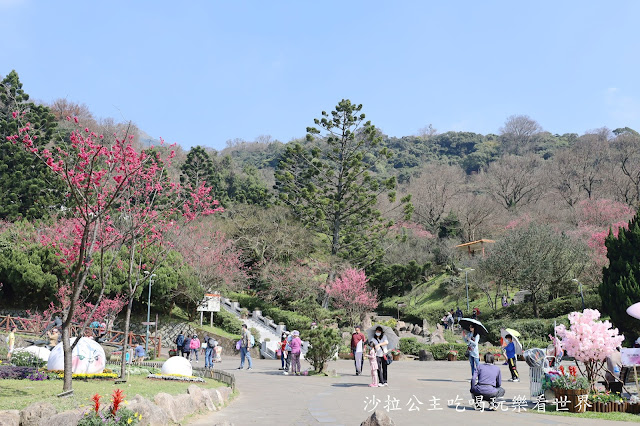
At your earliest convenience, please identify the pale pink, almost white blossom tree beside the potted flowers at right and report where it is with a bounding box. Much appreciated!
[556,309,624,392]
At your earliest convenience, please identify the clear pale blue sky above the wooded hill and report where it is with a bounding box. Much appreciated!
[0,0,640,149]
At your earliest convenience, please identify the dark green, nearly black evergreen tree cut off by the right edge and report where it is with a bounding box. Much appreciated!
[599,213,640,335]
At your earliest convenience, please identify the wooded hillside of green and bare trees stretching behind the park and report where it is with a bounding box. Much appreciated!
[0,71,640,342]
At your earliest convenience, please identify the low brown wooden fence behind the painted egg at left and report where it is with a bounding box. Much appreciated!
[0,315,162,356]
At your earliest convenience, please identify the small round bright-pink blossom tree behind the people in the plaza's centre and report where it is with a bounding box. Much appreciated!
[325,268,378,325]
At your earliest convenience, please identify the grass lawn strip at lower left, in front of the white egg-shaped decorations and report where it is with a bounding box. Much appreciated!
[0,376,224,411]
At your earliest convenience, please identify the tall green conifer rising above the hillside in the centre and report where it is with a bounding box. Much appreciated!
[275,99,409,266]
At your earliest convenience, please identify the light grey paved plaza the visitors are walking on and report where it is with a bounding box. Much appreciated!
[190,358,621,426]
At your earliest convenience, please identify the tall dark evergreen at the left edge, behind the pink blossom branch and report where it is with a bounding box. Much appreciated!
[0,71,64,220]
